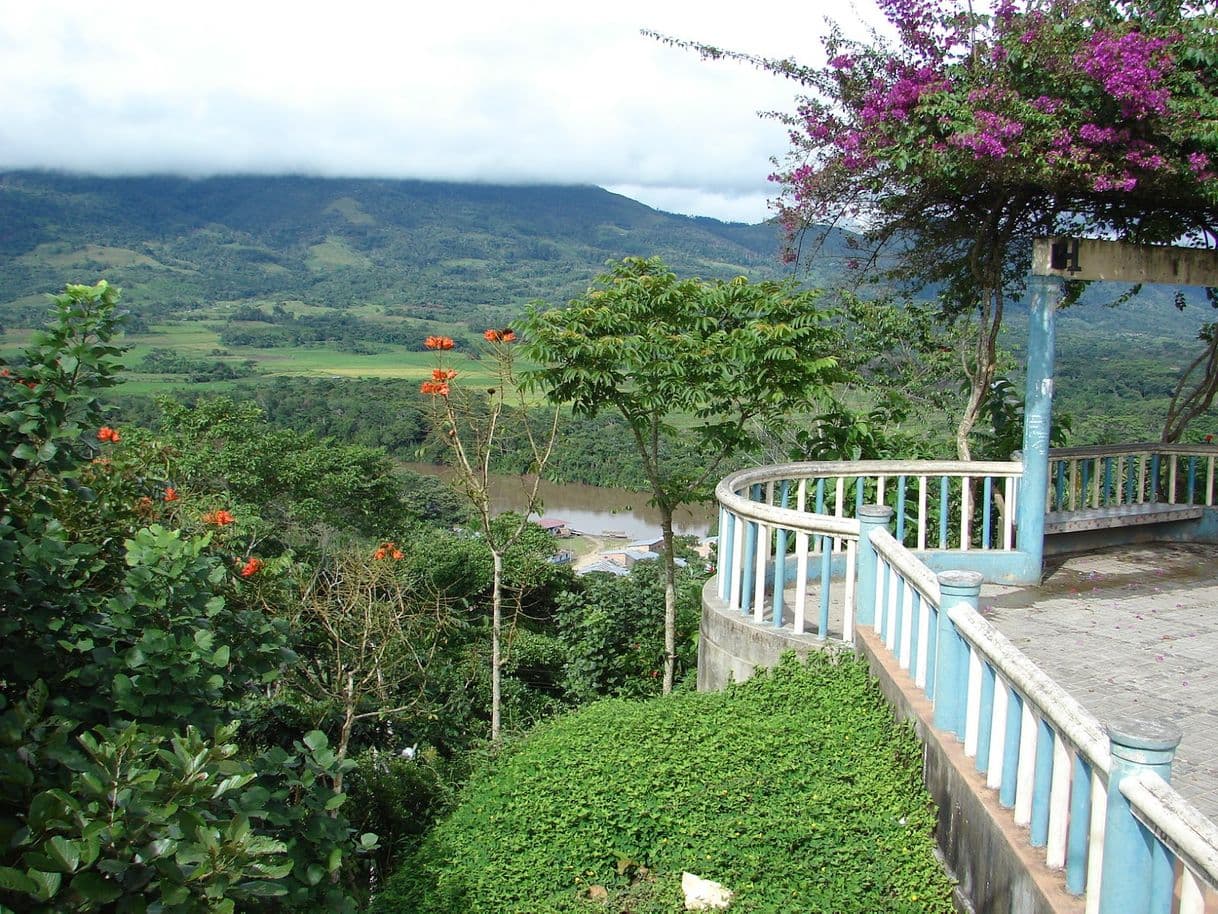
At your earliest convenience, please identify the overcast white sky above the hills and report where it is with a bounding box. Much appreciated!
[0,0,877,222]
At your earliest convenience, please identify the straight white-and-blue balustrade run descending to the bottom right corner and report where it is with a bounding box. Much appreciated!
[857,514,1218,914]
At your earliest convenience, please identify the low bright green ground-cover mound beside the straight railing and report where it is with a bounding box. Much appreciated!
[373,654,952,914]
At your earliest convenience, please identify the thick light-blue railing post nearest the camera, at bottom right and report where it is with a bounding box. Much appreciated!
[1100,719,1181,914]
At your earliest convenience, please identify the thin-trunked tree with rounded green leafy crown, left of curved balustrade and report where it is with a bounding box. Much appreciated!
[521,257,845,693]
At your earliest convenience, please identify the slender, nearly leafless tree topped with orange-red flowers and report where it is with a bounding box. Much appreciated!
[420,328,558,741]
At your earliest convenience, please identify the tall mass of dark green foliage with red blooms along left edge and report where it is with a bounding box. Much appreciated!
[0,283,375,912]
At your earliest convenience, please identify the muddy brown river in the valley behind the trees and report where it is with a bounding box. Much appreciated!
[402,463,714,540]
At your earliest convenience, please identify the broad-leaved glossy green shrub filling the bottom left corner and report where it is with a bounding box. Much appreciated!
[0,724,292,914]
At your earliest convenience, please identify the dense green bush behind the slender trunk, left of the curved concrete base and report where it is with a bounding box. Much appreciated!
[557,562,704,703]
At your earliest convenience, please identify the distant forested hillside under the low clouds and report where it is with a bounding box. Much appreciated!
[0,172,828,323]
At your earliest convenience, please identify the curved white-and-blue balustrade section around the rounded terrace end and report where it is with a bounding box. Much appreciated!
[716,461,1022,640]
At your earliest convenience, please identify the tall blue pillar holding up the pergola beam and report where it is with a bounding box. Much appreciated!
[1016,275,1061,584]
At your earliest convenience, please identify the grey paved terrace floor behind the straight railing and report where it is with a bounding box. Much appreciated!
[980,544,1218,821]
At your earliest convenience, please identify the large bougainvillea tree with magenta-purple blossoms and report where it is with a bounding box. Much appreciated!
[657,0,1218,457]
